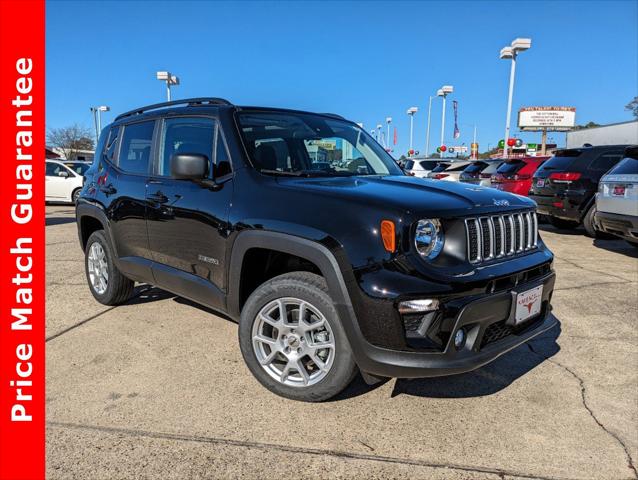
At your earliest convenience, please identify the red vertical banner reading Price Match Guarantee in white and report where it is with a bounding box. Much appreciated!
[0,0,45,480]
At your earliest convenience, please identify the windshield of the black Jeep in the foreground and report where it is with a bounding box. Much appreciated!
[237,112,403,176]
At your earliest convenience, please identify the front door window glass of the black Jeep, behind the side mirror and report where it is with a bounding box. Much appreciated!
[156,117,215,176]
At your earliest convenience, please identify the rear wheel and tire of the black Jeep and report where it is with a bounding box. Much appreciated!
[84,230,135,305]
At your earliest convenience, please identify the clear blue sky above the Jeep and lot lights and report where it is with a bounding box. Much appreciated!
[46,0,638,156]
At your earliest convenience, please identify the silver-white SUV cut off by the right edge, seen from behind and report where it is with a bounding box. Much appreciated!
[594,145,638,247]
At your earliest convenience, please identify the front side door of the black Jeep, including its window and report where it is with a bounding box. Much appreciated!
[146,117,233,307]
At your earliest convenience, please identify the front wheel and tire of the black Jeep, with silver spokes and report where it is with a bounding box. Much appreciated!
[239,272,357,402]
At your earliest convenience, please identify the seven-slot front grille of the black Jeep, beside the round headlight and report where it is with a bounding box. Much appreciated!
[465,211,538,263]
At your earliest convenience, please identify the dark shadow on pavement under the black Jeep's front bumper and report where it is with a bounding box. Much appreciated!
[392,321,561,398]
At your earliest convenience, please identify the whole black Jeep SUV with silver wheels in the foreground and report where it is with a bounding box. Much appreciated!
[76,98,555,401]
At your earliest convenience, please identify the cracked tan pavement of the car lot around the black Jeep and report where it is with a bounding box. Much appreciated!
[46,206,638,479]
